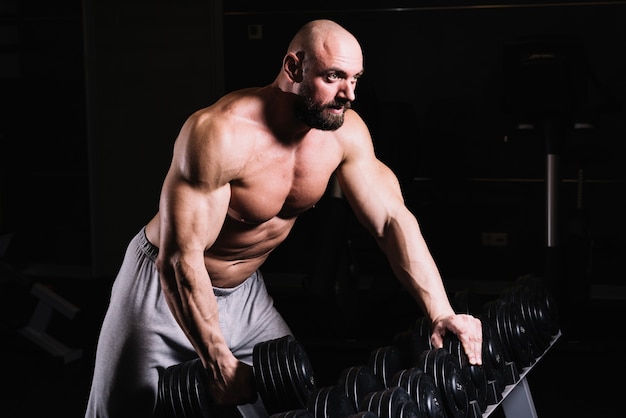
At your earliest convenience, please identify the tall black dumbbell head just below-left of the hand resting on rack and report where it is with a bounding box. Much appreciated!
[417,348,470,418]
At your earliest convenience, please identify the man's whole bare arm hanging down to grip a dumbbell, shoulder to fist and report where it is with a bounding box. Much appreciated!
[157,113,255,403]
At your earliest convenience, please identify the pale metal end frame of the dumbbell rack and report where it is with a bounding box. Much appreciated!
[483,332,561,418]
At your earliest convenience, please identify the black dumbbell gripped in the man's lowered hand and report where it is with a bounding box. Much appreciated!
[158,335,316,418]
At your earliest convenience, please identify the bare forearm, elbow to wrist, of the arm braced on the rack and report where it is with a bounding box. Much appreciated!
[378,210,454,320]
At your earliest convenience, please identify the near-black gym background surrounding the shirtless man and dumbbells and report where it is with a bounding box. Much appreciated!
[0,0,626,417]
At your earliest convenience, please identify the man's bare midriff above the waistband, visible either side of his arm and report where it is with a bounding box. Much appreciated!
[146,214,296,288]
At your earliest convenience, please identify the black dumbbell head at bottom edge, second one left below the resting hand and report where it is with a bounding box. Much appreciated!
[391,367,446,418]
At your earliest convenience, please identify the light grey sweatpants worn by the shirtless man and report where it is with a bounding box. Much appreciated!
[85,228,291,418]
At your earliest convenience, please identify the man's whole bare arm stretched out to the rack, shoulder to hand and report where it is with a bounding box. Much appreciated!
[337,112,482,364]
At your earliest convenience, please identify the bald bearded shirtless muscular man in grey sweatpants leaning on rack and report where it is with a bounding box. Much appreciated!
[86,20,482,417]
